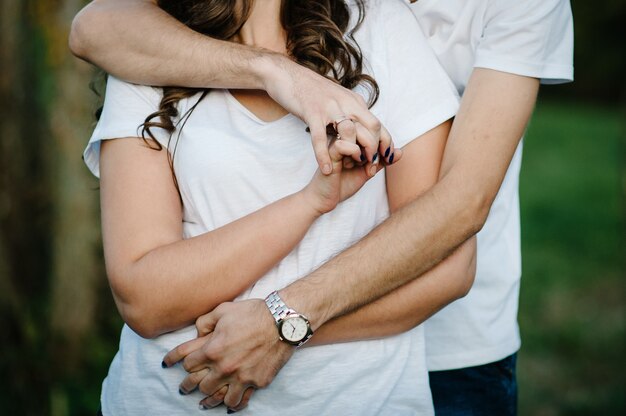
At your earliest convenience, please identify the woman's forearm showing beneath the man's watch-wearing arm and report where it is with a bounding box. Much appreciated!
[307,237,476,346]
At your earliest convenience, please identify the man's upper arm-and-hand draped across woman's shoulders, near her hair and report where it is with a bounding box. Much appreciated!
[69,0,392,174]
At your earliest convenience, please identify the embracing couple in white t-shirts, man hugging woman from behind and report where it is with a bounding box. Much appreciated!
[70,0,573,416]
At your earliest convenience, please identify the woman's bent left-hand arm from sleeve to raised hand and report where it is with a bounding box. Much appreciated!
[100,132,378,337]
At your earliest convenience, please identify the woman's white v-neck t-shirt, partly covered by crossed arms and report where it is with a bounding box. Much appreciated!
[84,0,459,416]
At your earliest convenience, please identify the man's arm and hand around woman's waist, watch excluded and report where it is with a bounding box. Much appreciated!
[165,69,539,408]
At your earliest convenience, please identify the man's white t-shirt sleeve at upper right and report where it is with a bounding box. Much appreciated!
[474,0,574,84]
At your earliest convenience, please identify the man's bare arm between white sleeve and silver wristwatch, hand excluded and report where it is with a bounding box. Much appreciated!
[280,69,538,329]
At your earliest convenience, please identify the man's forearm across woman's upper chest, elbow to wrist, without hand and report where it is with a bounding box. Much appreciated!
[70,0,278,89]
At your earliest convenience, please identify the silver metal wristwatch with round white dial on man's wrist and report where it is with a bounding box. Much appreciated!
[265,291,313,347]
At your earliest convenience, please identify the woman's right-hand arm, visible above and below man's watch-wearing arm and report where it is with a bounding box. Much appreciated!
[307,122,476,345]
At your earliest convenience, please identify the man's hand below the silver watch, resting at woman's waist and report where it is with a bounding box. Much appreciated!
[163,299,295,410]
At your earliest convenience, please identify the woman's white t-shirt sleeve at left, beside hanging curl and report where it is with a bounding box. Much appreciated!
[83,76,169,177]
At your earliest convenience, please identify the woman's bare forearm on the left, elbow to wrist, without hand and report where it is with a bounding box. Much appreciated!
[107,193,319,337]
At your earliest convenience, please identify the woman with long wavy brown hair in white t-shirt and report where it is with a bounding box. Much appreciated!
[84,0,470,416]
